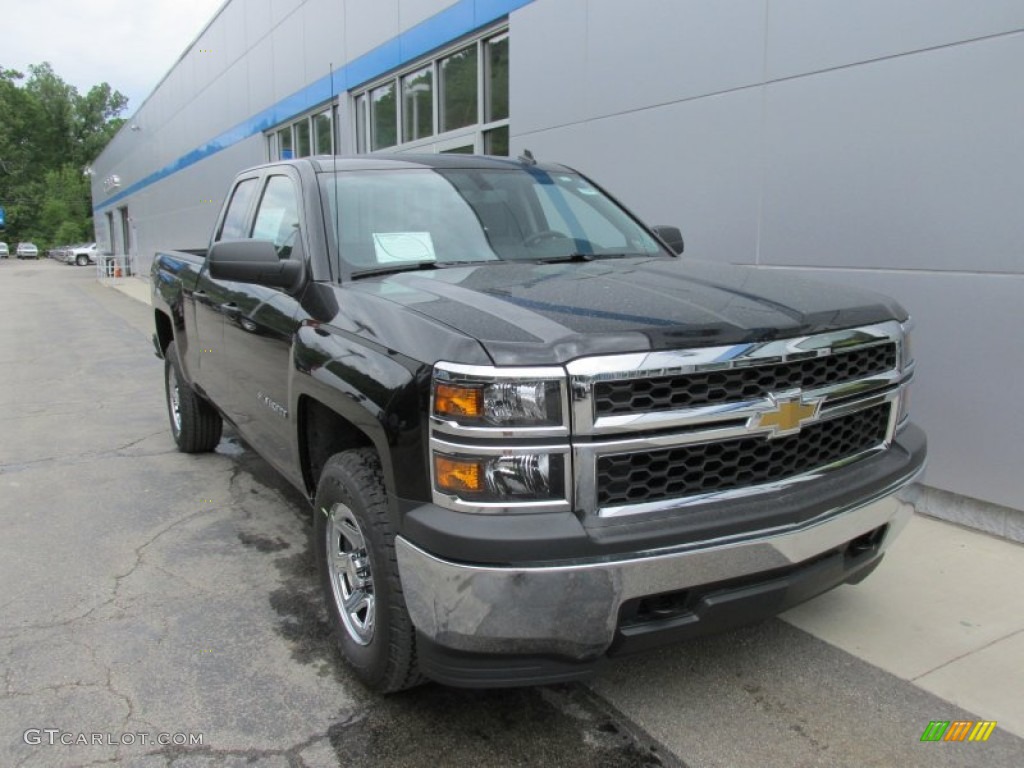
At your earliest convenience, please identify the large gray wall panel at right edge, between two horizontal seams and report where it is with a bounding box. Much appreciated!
[761,35,1024,272]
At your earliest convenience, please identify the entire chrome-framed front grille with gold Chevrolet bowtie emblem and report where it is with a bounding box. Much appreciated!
[566,321,913,518]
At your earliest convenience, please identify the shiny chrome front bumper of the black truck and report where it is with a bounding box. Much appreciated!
[395,493,911,660]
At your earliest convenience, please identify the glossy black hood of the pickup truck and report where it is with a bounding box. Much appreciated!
[351,258,906,366]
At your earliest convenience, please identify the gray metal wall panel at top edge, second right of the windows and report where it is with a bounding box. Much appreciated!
[589,0,767,117]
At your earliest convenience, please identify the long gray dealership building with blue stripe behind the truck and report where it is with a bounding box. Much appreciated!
[91,0,1024,541]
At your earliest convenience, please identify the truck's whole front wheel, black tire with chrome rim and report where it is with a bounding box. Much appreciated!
[313,449,423,693]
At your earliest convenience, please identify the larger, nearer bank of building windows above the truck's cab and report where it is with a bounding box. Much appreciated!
[352,29,509,156]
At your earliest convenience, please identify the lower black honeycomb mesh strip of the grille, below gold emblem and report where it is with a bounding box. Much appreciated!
[597,403,891,507]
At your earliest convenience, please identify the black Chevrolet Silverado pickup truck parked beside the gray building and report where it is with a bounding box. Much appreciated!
[153,155,926,691]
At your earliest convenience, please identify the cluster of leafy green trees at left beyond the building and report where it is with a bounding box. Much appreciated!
[0,62,128,248]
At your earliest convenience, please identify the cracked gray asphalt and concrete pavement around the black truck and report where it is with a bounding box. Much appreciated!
[0,260,1024,768]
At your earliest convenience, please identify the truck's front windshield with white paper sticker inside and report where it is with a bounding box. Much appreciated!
[321,168,667,274]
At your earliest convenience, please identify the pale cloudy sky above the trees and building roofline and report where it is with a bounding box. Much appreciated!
[0,0,224,118]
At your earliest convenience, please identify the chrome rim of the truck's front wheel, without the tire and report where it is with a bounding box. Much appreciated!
[325,503,376,645]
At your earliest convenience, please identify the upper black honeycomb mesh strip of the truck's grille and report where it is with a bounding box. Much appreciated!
[594,343,896,417]
